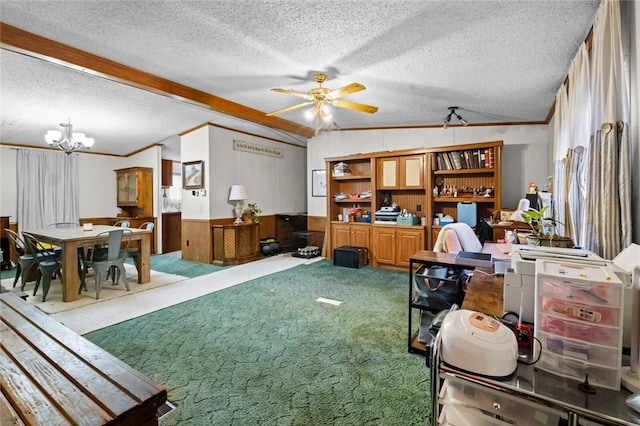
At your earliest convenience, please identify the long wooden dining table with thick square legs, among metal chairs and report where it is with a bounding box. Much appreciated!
[24,225,151,302]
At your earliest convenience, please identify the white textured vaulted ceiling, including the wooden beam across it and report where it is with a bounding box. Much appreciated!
[0,0,600,159]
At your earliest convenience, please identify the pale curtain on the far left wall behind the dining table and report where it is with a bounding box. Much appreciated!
[17,149,79,231]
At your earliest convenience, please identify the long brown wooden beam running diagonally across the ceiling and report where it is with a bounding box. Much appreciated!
[0,22,315,138]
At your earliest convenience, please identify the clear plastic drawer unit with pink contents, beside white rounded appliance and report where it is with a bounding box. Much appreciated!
[534,259,623,390]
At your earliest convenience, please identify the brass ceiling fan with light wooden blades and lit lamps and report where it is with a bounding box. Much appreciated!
[267,74,378,119]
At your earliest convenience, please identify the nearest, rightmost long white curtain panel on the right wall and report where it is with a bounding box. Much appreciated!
[585,0,632,259]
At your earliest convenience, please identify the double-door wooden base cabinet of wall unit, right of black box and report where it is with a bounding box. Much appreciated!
[372,225,425,267]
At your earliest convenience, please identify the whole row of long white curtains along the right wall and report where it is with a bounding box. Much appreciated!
[554,0,632,259]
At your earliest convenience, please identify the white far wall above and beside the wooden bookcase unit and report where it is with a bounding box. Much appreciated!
[307,124,552,216]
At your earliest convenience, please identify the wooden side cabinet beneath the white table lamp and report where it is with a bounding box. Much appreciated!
[211,223,261,266]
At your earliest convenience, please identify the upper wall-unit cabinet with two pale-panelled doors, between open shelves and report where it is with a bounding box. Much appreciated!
[377,154,424,190]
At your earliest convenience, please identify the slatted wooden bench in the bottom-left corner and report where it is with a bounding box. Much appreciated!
[0,293,167,426]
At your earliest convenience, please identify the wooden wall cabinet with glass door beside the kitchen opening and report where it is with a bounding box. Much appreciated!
[115,167,153,217]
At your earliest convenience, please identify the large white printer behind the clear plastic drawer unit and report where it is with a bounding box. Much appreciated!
[503,244,632,347]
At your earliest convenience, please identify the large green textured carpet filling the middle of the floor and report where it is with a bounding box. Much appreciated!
[85,260,430,426]
